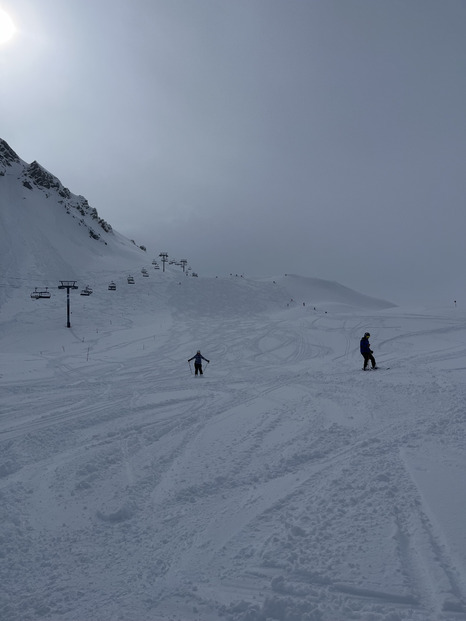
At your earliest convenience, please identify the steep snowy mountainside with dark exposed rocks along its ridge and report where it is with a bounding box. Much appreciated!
[0,139,147,298]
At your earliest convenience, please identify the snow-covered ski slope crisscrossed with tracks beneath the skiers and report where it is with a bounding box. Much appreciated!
[0,268,466,621]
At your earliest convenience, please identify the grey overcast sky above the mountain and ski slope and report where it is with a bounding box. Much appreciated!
[0,0,466,304]
